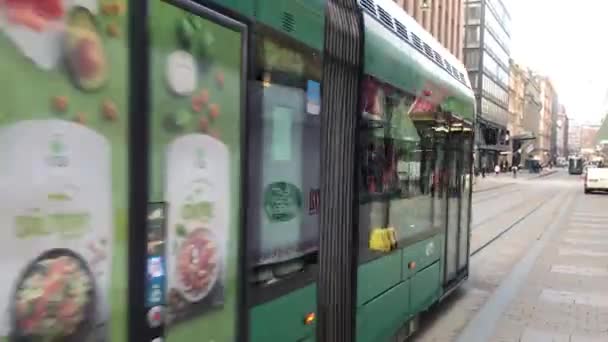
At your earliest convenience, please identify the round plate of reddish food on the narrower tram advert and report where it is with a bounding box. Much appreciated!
[173,224,222,303]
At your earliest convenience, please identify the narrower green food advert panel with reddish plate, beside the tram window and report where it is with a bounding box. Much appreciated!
[150,1,244,341]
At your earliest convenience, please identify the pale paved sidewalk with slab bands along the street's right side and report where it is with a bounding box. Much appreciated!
[490,191,608,342]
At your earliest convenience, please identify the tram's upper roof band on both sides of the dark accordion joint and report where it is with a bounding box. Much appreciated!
[209,0,475,122]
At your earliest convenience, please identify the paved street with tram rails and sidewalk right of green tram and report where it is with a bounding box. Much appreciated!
[412,169,608,342]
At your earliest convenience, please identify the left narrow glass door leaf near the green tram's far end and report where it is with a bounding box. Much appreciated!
[445,131,462,283]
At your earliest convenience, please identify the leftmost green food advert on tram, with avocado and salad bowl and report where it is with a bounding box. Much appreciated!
[0,0,128,342]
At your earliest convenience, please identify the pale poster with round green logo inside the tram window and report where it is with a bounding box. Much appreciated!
[249,82,320,268]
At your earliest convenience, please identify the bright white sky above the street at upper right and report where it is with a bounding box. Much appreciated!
[503,0,608,122]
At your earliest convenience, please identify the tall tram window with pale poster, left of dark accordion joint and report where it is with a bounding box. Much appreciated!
[247,31,321,286]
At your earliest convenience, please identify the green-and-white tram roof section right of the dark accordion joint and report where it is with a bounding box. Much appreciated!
[359,0,474,121]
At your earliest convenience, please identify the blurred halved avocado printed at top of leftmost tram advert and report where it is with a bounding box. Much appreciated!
[65,7,108,91]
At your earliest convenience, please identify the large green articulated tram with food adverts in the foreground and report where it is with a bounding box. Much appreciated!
[0,0,475,342]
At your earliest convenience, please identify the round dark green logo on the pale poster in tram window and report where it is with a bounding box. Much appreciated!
[264,182,302,222]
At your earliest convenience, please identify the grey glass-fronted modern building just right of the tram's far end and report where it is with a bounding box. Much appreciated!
[464,0,511,168]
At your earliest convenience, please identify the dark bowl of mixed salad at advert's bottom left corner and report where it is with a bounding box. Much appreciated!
[10,249,97,342]
